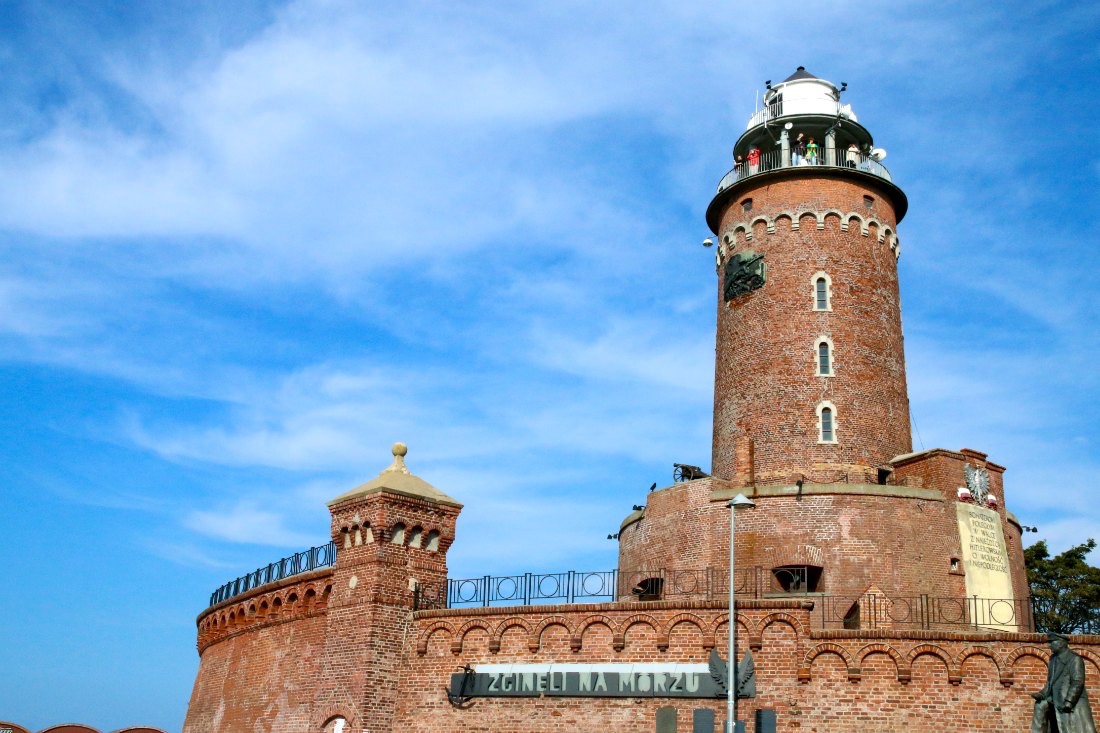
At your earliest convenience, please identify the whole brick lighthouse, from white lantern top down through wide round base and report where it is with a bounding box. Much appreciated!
[619,67,1027,611]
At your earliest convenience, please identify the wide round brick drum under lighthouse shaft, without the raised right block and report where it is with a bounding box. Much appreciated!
[619,479,966,613]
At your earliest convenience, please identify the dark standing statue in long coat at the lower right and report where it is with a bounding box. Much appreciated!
[1032,632,1097,733]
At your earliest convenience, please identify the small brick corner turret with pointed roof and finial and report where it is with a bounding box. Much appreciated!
[311,442,462,731]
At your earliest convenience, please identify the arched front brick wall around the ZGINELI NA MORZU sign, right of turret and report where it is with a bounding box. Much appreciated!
[394,601,1100,733]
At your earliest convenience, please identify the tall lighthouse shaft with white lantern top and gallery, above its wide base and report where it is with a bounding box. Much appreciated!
[706,67,912,485]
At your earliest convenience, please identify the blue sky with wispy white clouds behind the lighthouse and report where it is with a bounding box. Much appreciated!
[0,0,1100,731]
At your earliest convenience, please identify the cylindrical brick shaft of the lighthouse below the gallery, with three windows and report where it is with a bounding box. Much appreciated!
[712,174,912,485]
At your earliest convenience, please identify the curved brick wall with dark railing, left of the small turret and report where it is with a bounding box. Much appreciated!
[184,568,333,733]
